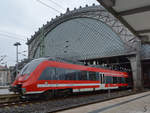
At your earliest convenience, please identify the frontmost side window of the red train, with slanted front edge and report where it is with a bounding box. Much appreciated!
[38,67,55,80]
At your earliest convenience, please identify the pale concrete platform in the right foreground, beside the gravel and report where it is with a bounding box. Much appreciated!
[59,91,150,113]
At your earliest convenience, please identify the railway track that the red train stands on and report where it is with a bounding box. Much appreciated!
[0,89,123,108]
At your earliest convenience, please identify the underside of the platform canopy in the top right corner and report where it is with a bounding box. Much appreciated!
[97,0,150,42]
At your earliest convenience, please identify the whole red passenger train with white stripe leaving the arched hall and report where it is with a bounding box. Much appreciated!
[12,58,128,95]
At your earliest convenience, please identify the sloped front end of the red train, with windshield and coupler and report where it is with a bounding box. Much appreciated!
[9,58,47,95]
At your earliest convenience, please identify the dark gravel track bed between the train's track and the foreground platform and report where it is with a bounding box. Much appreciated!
[0,90,148,113]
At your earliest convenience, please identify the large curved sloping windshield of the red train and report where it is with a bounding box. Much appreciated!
[19,58,47,75]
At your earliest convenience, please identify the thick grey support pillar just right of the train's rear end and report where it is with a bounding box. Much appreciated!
[129,41,143,91]
